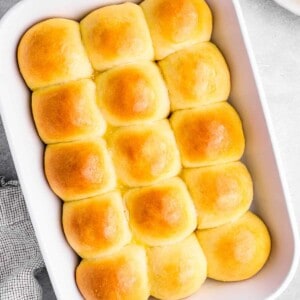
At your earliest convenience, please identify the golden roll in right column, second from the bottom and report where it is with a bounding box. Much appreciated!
[184,162,253,229]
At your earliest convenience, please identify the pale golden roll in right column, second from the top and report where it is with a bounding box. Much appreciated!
[159,42,230,110]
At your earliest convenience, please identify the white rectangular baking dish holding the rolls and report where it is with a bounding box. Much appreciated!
[0,0,298,300]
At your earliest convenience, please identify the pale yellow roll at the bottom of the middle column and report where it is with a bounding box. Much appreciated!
[147,234,207,300]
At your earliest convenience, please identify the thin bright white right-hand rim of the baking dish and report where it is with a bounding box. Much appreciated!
[232,0,300,299]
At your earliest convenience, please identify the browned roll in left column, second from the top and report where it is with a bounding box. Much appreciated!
[32,79,106,144]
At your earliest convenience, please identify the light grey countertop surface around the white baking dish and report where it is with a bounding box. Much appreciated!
[0,0,300,300]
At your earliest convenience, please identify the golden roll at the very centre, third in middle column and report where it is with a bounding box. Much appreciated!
[110,120,181,186]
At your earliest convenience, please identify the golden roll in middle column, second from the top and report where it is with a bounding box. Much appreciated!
[96,62,170,126]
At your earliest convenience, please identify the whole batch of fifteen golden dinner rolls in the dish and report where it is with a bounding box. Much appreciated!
[18,0,270,300]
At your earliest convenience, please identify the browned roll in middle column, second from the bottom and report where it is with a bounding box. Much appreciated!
[124,177,197,246]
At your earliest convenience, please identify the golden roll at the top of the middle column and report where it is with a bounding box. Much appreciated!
[80,2,154,71]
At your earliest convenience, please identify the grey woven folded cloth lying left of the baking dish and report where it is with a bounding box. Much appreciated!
[0,177,44,300]
